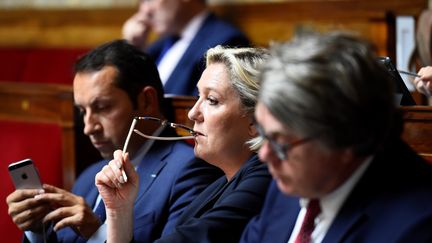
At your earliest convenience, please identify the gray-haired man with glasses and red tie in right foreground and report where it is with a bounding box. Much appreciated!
[241,33,432,243]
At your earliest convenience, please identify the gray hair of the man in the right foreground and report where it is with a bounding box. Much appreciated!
[259,32,396,156]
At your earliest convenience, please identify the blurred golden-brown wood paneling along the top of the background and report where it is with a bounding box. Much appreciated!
[0,0,427,55]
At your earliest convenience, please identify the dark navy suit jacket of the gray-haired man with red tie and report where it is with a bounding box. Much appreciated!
[241,141,432,243]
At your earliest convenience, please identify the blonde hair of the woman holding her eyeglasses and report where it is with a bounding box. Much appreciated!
[206,45,269,151]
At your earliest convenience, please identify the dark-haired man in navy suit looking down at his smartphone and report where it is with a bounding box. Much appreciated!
[8,41,221,242]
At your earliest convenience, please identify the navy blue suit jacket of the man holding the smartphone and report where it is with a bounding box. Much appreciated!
[37,138,222,242]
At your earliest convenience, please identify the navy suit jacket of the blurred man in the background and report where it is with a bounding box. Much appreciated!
[147,14,249,95]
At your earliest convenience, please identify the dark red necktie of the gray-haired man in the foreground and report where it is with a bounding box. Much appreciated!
[295,199,321,243]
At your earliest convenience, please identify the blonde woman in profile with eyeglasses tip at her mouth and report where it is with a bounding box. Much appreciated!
[96,46,271,242]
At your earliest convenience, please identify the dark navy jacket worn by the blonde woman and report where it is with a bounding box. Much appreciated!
[156,156,271,243]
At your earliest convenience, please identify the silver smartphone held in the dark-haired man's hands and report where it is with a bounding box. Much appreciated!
[8,159,42,189]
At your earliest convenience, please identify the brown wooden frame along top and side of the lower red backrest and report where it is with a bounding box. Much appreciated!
[0,81,75,189]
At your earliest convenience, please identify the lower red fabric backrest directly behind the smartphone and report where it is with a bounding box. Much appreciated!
[0,121,62,242]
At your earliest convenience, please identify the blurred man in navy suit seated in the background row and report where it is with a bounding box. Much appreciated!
[123,0,249,95]
